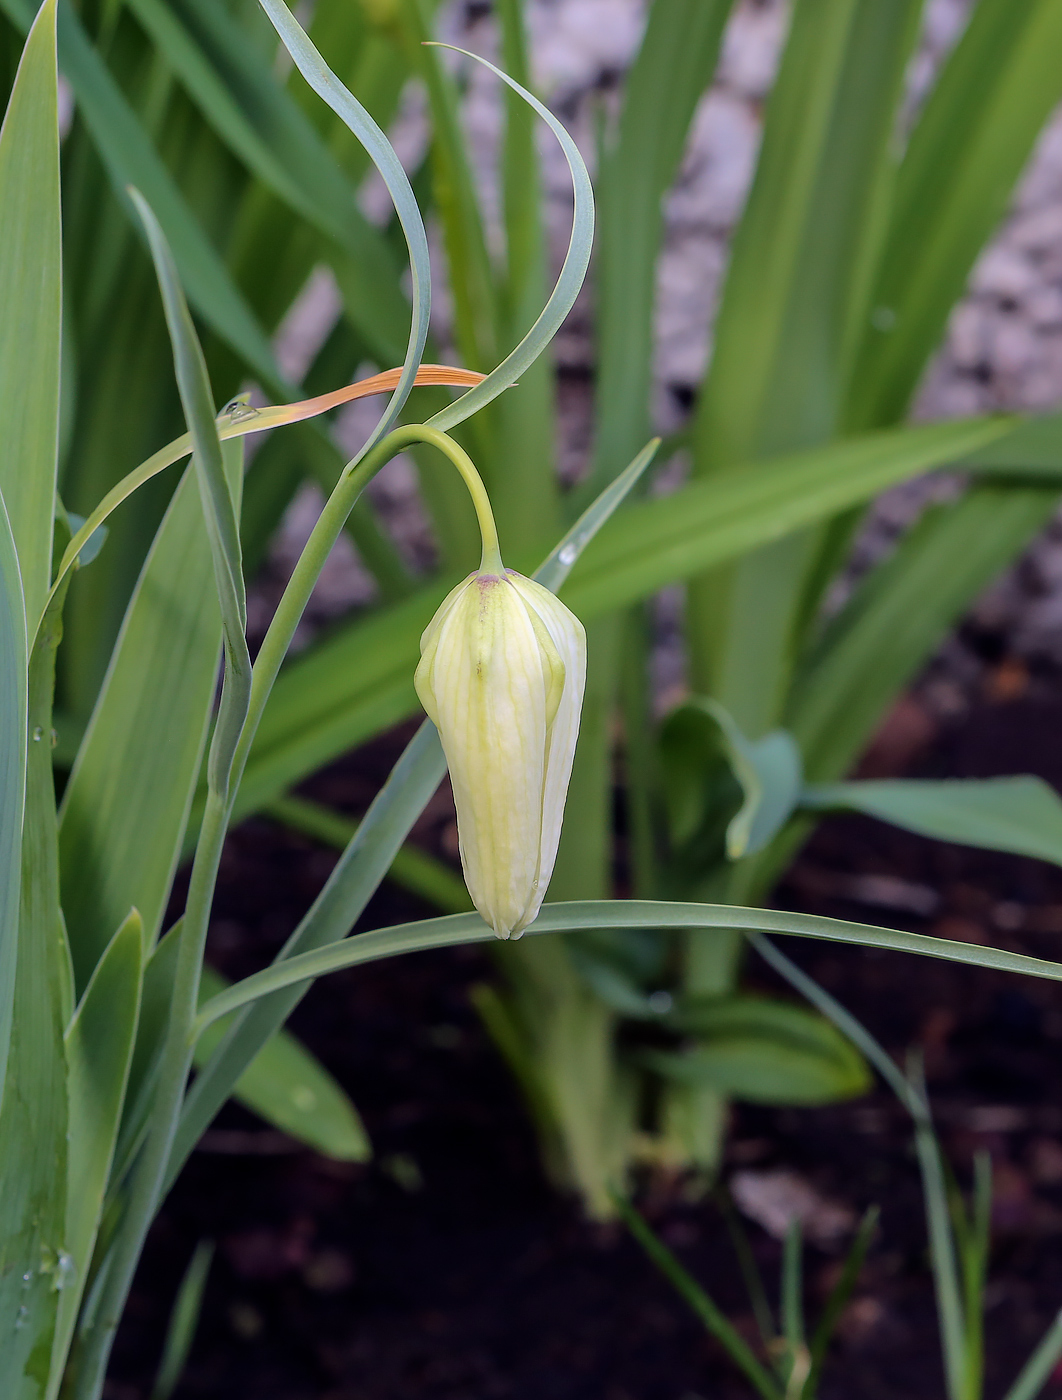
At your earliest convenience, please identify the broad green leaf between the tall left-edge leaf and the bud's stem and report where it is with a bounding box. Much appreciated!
[60,440,243,987]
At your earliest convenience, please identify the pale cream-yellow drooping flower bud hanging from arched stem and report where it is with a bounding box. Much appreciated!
[414,568,586,938]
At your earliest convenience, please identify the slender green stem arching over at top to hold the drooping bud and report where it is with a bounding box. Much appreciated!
[71,424,502,1400]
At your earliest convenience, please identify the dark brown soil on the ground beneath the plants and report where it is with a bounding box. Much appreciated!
[101,687,1062,1400]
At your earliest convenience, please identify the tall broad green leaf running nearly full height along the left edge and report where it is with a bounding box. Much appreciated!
[0,8,70,1400]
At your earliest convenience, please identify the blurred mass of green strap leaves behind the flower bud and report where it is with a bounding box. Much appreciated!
[10,0,1062,1214]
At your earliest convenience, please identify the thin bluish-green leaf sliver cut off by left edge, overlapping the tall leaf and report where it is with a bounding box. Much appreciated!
[0,494,28,1103]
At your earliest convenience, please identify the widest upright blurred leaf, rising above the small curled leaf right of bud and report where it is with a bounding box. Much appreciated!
[688,0,921,738]
